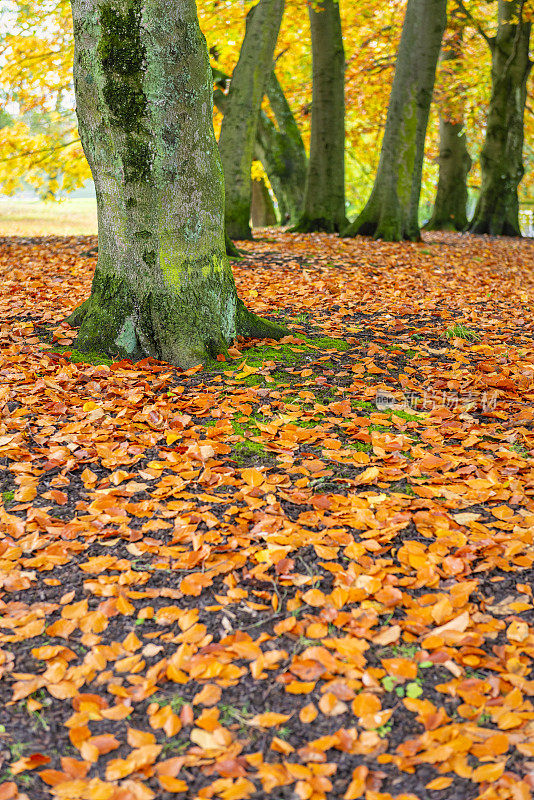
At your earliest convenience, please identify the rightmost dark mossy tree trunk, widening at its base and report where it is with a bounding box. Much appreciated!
[471,0,532,236]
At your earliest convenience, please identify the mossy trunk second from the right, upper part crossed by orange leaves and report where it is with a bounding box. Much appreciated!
[425,20,473,231]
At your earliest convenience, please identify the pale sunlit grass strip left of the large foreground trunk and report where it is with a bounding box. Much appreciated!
[0,198,97,236]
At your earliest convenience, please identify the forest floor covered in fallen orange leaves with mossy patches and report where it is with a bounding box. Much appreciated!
[0,230,534,800]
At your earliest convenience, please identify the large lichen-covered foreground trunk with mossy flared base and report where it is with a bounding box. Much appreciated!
[69,0,282,367]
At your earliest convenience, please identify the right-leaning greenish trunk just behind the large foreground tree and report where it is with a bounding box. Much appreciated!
[219,0,284,239]
